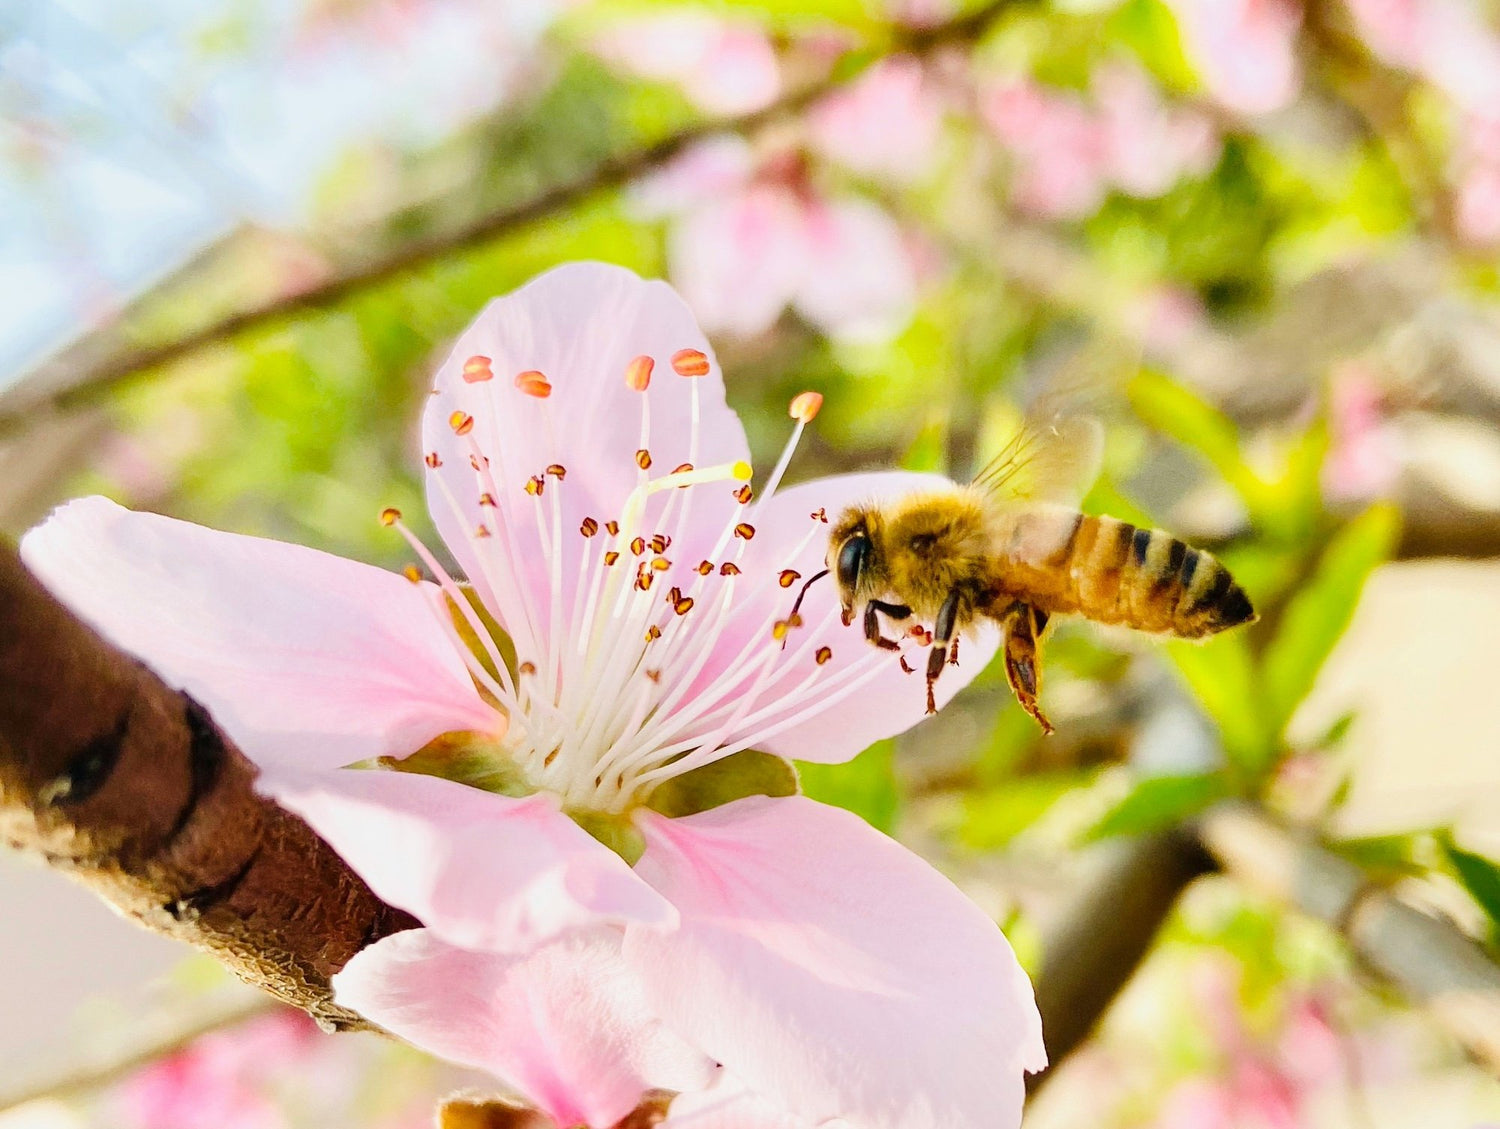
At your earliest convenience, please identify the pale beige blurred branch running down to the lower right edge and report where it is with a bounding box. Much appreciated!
[1200,804,1500,1072]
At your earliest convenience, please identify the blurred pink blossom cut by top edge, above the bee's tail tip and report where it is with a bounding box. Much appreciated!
[1167,0,1302,115]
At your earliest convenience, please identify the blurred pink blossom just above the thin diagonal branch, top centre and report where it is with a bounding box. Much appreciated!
[594,9,782,115]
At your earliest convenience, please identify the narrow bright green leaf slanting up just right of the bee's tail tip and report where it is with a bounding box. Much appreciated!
[1262,502,1401,733]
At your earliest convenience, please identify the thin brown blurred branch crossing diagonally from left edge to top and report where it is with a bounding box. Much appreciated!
[0,0,1029,438]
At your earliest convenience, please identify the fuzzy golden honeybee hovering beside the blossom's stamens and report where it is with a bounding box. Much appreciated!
[798,417,1256,733]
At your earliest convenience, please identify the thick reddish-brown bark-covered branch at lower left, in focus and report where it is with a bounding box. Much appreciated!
[0,544,416,1029]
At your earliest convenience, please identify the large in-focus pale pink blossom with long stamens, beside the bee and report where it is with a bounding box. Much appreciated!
[23,264,1046,1129]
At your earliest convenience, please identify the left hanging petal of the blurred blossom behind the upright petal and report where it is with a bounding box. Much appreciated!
[668,184,807,337]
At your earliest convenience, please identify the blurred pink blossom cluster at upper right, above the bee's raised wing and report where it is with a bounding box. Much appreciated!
[981,60,1220,219]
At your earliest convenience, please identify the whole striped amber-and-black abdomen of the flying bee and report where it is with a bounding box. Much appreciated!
[1008,507,1256,639]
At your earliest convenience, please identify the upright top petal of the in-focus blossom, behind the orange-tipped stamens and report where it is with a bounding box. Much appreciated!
[423,262,750,663]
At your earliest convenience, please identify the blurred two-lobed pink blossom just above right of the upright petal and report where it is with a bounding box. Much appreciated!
[636,138,917,340]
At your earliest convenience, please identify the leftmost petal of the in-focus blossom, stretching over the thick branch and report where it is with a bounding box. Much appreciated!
[21,498,504,768]
